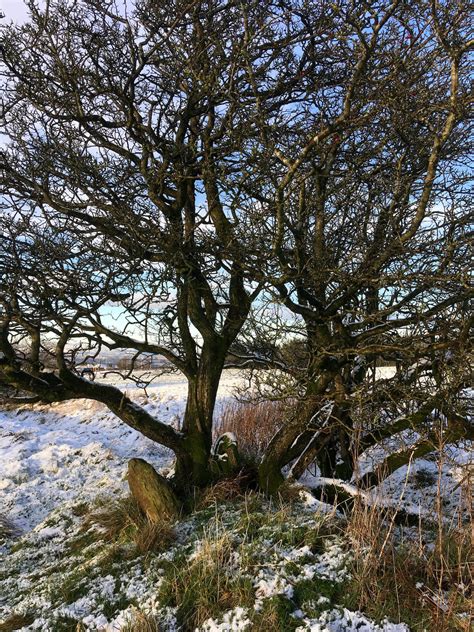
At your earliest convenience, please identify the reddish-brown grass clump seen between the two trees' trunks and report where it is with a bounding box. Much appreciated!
[214,401,286,461]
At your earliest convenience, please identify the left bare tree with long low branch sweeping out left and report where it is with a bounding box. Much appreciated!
[0,0,286,488]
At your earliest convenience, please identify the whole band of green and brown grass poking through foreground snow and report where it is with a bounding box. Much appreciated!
[0,456,474,632]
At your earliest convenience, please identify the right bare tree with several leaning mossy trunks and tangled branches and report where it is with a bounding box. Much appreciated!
[231,0,474,490]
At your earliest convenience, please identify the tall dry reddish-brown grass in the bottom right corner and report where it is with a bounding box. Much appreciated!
[345,496,474,632]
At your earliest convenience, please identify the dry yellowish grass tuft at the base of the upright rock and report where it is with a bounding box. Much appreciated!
[83,497,175,554]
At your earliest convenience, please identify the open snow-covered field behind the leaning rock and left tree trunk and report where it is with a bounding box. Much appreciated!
[0,371,239,531]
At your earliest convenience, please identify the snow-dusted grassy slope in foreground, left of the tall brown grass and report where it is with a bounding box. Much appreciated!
[0,486,386,632]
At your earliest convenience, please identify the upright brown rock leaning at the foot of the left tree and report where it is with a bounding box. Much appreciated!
[128,459,179,523]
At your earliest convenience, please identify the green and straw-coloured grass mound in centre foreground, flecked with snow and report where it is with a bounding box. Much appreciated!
[158,493,346,631]
